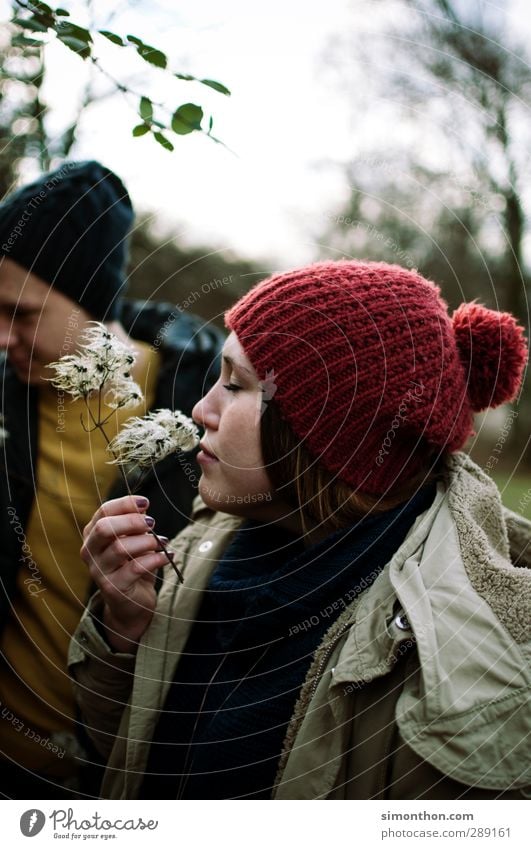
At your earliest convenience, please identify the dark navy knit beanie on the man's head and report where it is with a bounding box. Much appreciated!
[0,161,134,321]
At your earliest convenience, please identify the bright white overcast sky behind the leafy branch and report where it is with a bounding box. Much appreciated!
[0,0,525,265]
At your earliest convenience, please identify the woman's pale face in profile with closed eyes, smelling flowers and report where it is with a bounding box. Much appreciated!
[192,333,282,519]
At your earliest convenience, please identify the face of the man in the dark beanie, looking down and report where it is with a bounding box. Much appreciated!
[0,256,91,385]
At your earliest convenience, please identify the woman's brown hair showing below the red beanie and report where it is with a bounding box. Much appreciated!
[260,401,445,530]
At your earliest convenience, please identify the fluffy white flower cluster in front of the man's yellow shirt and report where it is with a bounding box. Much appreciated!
[48,321,143,409]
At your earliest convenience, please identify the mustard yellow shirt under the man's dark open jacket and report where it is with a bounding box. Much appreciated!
[0,343,159,777]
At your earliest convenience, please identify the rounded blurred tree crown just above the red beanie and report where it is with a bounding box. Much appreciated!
[319,153,506,308]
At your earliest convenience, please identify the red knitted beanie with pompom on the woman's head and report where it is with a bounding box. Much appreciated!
[225,260,527,495]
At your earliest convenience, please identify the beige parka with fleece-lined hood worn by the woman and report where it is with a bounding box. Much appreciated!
[69,453,531,799]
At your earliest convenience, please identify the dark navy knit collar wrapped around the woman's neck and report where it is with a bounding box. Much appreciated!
[207,485,435,646]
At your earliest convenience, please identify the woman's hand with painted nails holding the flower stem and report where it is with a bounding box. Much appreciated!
[81,495,171,653]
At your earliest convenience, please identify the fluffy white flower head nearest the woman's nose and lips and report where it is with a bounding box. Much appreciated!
[107,410,199,466]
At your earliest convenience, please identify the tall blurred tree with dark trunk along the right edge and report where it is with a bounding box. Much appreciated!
[395,0,531,319]
